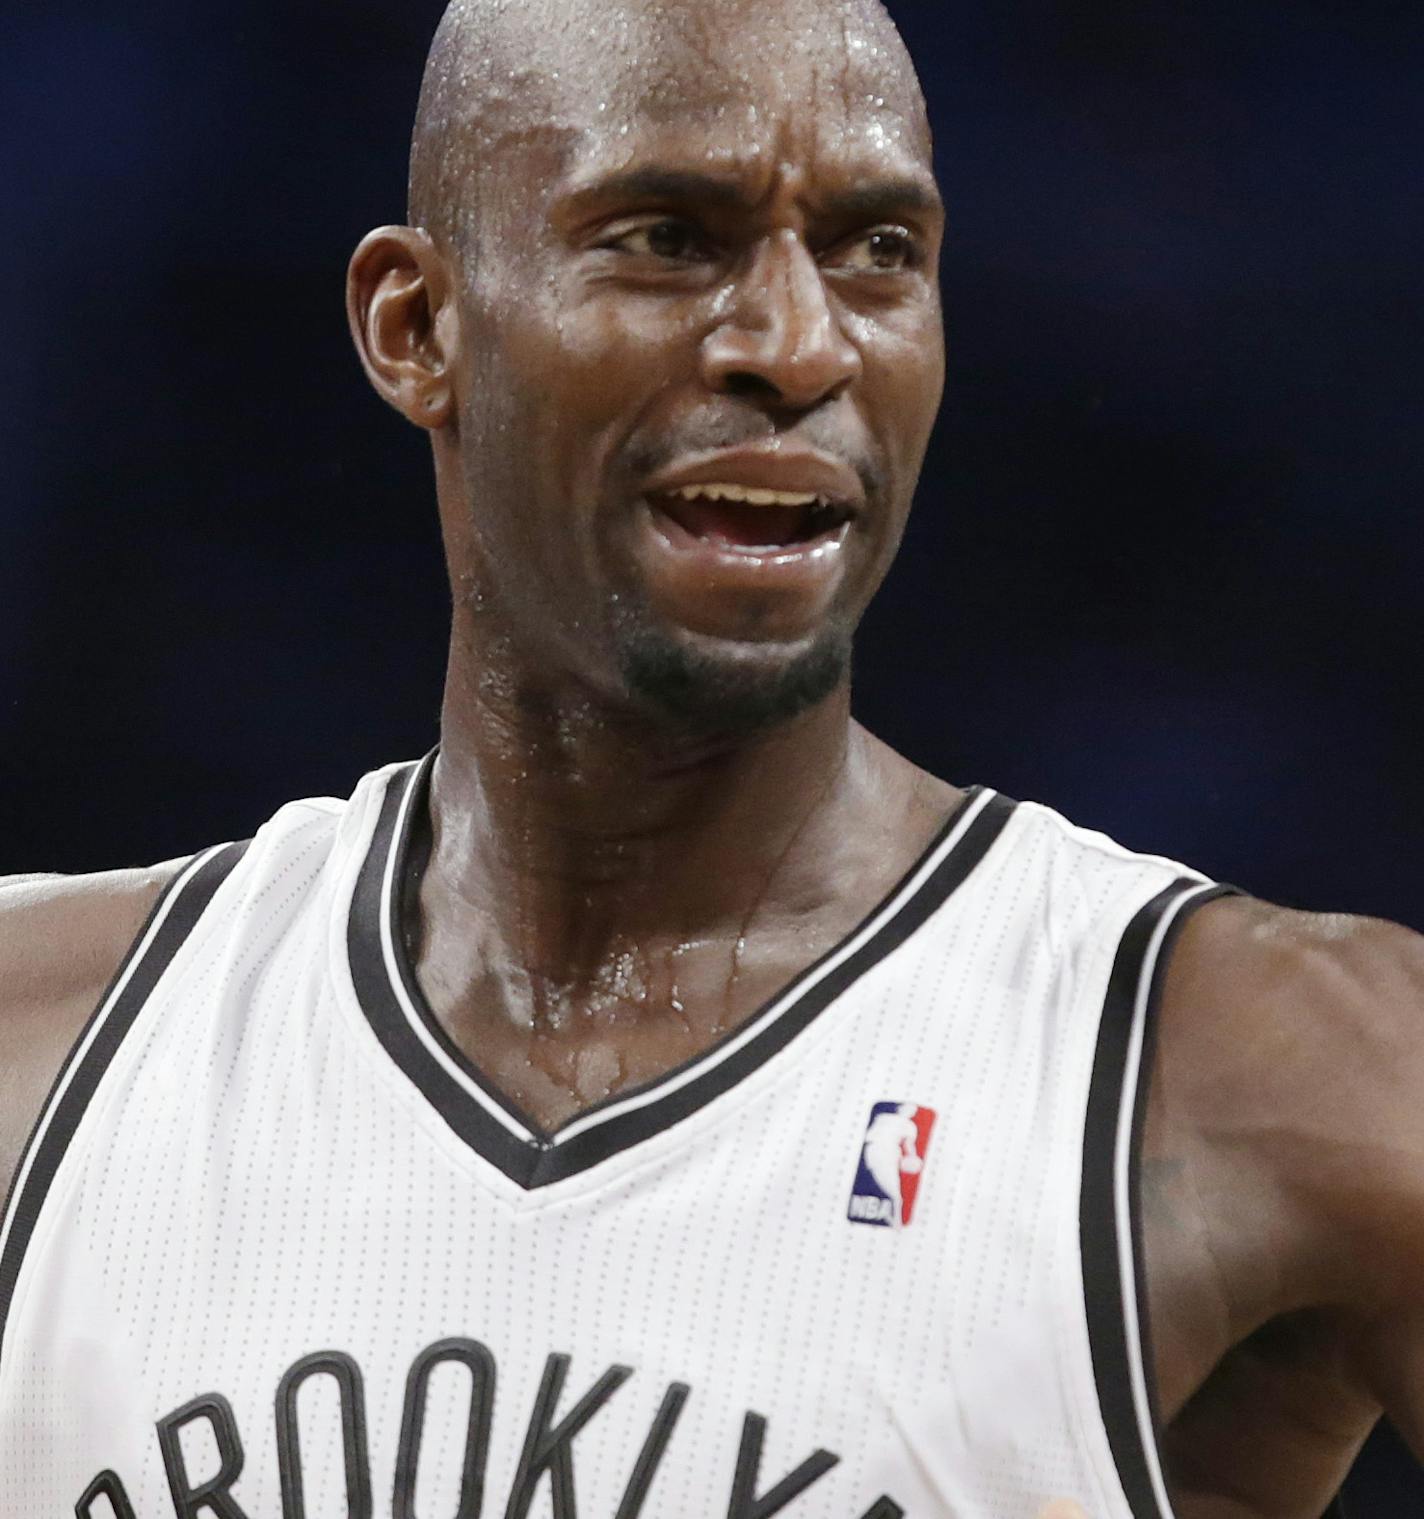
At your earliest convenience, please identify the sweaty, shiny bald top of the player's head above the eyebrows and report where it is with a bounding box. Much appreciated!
[416,0,930,217]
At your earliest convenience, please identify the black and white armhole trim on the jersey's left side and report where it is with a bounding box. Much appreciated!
[0,843,248,1353]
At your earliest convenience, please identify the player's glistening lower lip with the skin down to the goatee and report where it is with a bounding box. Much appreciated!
[635,501,850,638]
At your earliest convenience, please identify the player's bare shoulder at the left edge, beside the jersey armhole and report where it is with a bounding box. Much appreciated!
[0,860,184,1188]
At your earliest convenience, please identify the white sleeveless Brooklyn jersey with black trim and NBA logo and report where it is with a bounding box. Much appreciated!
[0,761,1219,1519]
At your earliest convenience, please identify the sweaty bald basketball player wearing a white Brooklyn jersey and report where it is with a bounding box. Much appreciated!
[0,0,1424,1519]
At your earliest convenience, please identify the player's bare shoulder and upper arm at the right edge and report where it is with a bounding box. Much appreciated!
[1138,898,1424,1514]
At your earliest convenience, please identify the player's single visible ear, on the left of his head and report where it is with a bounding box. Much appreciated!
[347,226,459,431]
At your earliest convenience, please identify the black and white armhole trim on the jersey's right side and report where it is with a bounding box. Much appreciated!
[1079,878,1234,1519]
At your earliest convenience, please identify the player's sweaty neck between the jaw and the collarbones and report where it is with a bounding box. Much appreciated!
[432,641,857,935]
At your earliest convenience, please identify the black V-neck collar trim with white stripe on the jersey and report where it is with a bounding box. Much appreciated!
[347,756,1015,1191]
